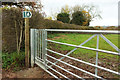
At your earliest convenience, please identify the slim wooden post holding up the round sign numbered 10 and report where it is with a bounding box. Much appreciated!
[25,18,29,67]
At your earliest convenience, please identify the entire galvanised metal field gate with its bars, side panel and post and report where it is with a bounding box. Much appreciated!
[30,29,120,80]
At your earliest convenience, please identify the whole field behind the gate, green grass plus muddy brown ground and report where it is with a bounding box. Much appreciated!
[48,33,119,78]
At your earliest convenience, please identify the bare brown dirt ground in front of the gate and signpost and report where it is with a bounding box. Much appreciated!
[2,67,53,78]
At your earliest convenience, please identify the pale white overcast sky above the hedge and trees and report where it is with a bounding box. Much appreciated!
[41,0,119,26]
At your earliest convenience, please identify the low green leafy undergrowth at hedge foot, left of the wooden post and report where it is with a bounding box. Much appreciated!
[2,52,25,70]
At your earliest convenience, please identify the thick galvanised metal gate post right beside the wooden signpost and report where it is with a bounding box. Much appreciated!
[30,29,35,67]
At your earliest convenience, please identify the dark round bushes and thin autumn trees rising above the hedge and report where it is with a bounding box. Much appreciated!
[48,5,102,26]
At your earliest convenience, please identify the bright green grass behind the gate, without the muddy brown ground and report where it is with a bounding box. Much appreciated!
[48,33,118,59]
